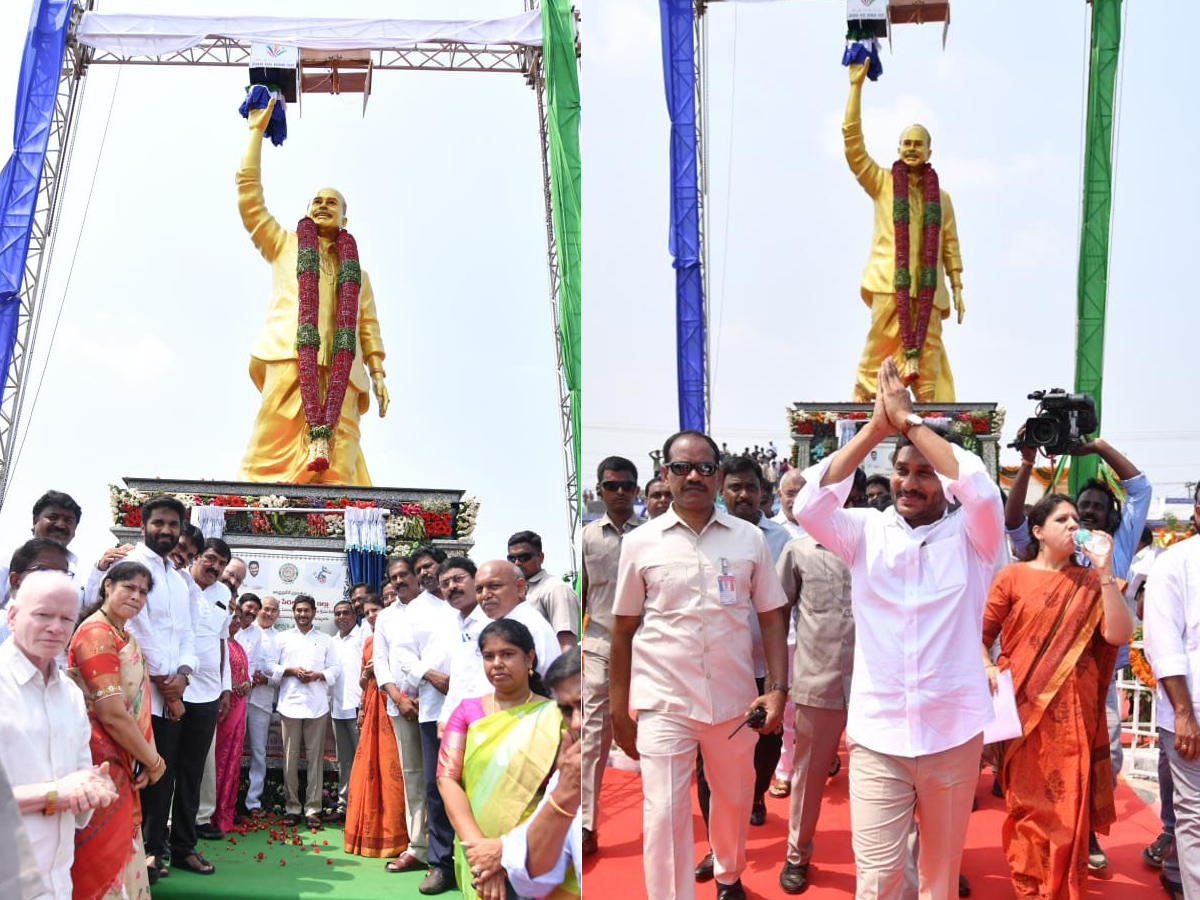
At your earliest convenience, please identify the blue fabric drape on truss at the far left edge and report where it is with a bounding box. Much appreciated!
[0,0,71,412]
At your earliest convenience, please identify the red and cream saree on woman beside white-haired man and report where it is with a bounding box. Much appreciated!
[67,612,152,900]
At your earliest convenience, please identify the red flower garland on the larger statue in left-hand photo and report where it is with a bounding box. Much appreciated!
[296,216,362,472]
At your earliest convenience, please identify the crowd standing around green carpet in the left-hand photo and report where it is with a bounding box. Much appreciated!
[0,491,582,900]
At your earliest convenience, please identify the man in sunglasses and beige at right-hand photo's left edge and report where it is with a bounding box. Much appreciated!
[580,456,642,856]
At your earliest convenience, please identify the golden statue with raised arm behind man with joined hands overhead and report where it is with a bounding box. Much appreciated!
[841,65,965,403]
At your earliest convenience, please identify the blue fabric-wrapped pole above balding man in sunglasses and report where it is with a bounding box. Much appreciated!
[659,0,704,431]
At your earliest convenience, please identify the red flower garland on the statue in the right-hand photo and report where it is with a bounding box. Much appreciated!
[892,160,942,384]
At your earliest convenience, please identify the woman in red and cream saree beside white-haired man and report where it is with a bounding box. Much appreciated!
[67,562,167,900]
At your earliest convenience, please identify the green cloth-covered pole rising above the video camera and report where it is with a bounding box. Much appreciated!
[1068,0,1121,494]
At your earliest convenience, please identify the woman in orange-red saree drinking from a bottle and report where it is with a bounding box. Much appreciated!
[983,494,1133,900]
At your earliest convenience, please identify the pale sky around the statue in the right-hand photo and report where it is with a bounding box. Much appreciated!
[583,0,1200,511]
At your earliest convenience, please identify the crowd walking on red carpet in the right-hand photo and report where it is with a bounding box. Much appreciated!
[582,361,1200,900]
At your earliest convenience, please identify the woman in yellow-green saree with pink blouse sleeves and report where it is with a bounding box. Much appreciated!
[438,619,563,900]
